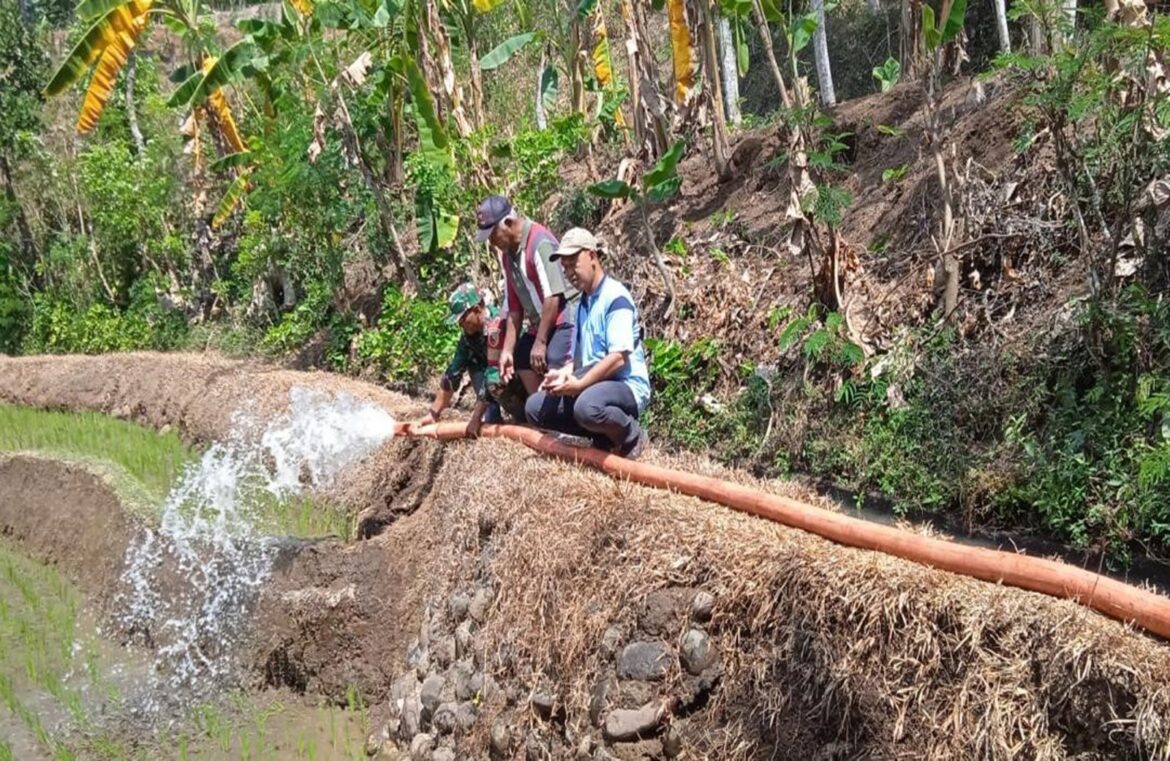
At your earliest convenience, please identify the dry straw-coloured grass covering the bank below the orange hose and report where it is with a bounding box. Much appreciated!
[433,441,1170,759]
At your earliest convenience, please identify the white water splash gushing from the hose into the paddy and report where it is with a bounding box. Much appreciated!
[119,386,394,707]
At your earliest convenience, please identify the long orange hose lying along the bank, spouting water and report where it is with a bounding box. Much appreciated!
[395,423,1170,639]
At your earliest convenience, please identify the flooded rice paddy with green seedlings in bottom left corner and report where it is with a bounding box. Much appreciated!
[0,540,369,761]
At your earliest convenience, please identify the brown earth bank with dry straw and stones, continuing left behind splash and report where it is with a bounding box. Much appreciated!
[0,355,1170,759]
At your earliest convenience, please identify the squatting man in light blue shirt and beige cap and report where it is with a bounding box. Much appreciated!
[524,227,651,459]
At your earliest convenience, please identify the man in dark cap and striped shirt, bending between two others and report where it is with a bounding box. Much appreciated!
[475,196,580,393]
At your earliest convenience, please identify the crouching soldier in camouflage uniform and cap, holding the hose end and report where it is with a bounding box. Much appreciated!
[418,283,527,437]
